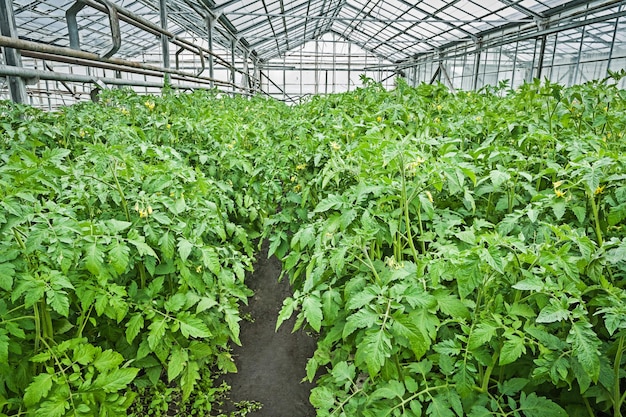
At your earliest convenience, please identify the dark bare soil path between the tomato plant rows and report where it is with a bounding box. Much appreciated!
[219,244,316,417]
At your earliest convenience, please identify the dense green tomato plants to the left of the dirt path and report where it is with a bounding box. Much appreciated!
[0,91,283,416]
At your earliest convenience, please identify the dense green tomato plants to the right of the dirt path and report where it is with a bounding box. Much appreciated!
[269,79,626,417]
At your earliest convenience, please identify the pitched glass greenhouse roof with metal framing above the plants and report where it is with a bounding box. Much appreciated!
[13,0,608,62]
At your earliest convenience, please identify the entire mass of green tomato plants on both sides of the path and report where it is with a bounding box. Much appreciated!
[0,74,626,417]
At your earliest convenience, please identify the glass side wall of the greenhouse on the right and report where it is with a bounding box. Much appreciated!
[405,2,626,90]
